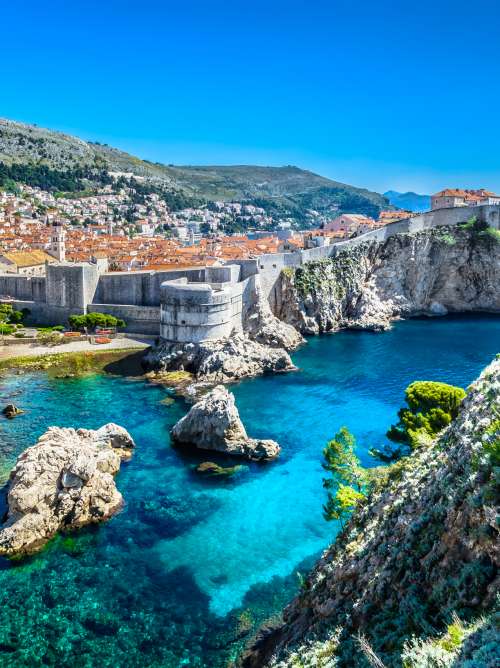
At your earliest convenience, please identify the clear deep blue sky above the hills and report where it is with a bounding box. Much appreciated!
[0,0,500,192]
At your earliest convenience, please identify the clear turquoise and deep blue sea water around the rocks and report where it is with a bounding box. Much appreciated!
[0,316,500,668]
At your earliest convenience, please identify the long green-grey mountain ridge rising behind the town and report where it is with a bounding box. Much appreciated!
[0,119,392,221]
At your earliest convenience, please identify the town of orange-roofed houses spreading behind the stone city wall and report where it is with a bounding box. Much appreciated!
[0,184,500,275]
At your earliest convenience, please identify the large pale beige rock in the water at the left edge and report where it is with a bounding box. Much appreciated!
[0,423,135,556]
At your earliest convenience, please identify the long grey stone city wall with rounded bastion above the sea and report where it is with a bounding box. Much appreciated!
[0,205,500,343]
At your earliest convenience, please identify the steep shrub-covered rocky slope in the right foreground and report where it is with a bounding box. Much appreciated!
[243,359,500,668]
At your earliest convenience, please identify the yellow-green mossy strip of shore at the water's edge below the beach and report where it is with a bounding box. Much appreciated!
[0,348,146,378]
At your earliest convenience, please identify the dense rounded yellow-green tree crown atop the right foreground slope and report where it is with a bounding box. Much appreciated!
[387,381,465,448]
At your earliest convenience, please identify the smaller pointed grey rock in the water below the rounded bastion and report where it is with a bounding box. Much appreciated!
[172,385,280,461]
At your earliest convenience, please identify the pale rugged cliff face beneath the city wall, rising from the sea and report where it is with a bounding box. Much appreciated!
[276,227,500,334]
